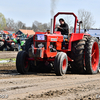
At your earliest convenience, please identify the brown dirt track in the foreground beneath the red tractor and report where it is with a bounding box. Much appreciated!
[0,52,100,100]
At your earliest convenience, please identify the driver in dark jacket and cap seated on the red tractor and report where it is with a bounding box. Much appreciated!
[57,18,69,45]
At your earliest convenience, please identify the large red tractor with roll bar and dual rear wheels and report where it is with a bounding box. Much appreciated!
[16,12,99,76]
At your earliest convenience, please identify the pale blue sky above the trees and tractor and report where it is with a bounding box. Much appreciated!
[0,0,100,28]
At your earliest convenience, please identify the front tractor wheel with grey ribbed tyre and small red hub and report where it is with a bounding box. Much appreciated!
[54,52,68,76]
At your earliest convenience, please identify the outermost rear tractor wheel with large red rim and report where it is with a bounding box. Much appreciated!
[85,37,99,74]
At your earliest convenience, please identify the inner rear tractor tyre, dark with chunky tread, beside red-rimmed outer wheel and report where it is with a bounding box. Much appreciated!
[70,37,87,74]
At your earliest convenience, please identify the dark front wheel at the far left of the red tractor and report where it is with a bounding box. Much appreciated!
[16,51,29,74]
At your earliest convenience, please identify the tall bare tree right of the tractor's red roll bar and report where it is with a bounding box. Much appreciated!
[78,9,95,29]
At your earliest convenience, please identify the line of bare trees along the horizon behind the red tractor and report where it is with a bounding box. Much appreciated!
[0,9,95,32]
